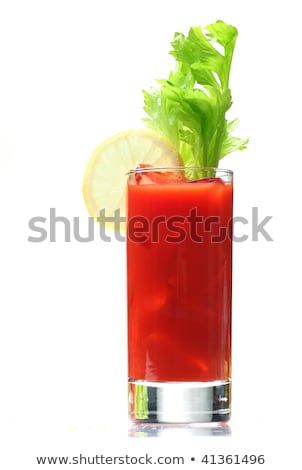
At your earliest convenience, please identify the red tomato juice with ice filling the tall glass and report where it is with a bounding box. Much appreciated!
[127,177,233,382]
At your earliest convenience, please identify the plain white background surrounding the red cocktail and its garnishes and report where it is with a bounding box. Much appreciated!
[0,0,302,470]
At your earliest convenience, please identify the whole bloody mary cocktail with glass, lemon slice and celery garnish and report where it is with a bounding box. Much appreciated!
[83,20,249,423]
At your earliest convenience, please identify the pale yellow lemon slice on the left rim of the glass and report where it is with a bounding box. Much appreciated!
[83,130,181,229]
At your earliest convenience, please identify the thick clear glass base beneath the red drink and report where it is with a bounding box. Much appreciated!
[129,379,231,423]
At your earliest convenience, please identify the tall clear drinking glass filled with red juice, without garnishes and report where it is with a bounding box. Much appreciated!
[127,167,233,423]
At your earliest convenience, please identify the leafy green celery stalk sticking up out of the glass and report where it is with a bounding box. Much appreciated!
[143,21,248,167]
